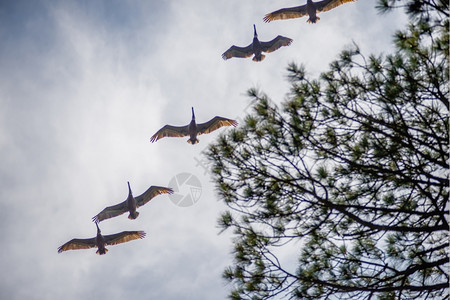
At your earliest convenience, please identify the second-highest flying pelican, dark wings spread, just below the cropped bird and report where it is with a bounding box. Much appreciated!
[222,24,292,61]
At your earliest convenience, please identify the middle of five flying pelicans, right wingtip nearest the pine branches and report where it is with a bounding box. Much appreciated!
[150,107,237,145]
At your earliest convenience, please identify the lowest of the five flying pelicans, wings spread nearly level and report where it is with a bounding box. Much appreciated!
[58,223,145,255]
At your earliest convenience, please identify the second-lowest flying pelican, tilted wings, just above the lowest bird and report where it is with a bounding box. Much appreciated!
[92,182,173,223]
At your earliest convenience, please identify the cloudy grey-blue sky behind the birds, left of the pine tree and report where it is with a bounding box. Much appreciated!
[0,0,407,300]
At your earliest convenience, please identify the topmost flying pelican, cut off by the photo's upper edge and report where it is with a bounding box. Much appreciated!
[263,0,356,23]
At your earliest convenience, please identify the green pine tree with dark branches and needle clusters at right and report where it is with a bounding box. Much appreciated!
[207,0,449,299]
